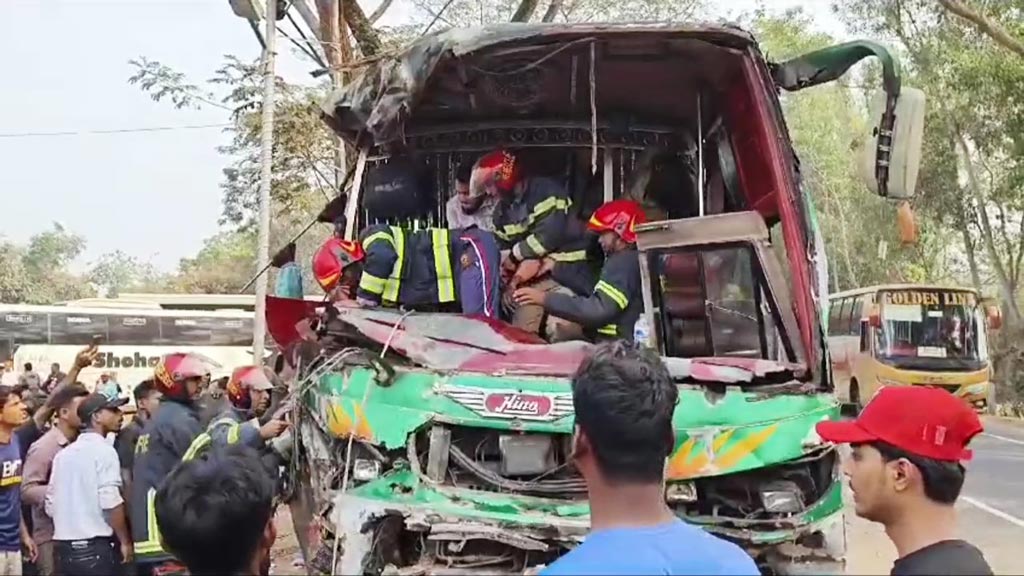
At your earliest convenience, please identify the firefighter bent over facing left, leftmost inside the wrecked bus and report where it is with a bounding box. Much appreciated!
[312,224,500,318]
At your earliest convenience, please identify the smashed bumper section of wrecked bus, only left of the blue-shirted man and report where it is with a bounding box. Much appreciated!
[333,475,590,576]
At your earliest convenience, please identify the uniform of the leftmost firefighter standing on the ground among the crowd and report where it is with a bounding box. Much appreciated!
[128,398,203,565]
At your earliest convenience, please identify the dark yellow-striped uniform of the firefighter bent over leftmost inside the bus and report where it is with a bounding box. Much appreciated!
[356,224,500,316]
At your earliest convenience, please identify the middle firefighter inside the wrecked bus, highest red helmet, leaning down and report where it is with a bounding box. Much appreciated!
[470,150,594,340]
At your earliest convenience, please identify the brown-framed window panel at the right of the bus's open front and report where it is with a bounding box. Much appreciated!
[637,212,812,381]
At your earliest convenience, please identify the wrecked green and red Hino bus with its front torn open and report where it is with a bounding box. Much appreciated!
[276,24,923,575]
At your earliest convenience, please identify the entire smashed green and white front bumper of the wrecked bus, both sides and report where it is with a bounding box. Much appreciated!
[323,472,846,576]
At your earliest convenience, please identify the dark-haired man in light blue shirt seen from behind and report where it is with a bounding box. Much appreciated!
[541,340,760,576]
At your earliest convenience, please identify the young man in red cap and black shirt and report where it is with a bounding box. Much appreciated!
[817,386,992,575]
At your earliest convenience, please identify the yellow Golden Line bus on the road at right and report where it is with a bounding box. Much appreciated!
[828,284,1001,411]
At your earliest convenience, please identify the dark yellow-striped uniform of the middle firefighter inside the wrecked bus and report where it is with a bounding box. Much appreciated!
[495,177,594,294]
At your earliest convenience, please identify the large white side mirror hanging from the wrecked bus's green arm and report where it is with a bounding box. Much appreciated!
[858,87,926,200]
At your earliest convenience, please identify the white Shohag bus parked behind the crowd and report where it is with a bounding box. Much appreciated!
[0,298,253,395]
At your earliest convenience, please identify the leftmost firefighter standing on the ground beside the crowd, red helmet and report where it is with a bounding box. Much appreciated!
[129,353,210,574]
